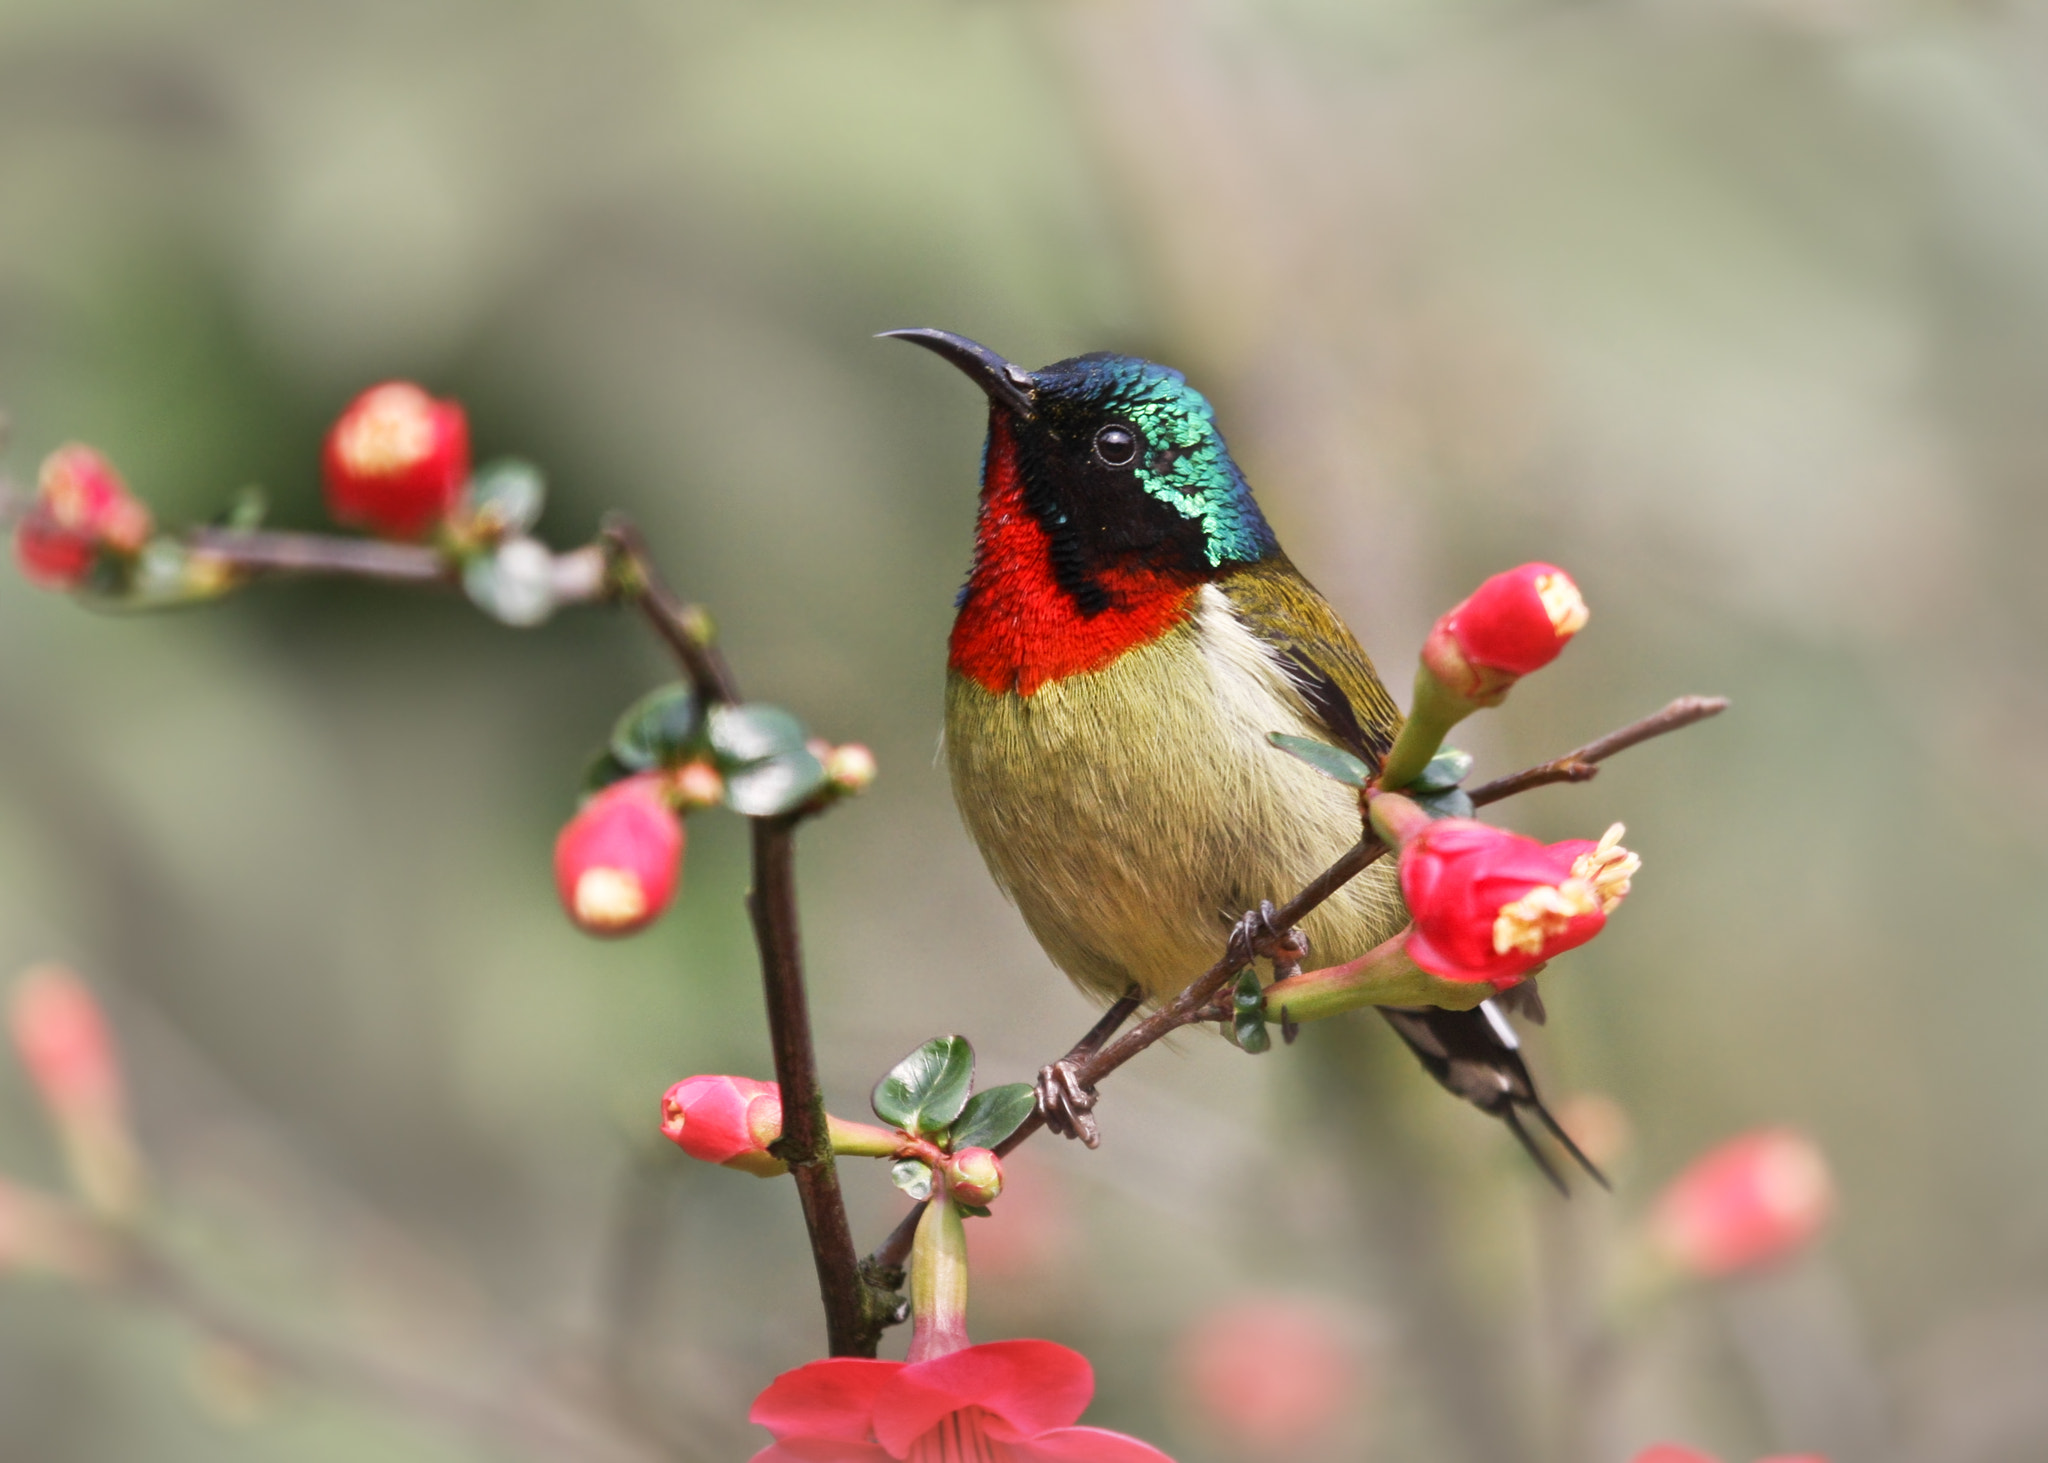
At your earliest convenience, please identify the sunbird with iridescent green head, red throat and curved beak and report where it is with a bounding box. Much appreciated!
[887,330,1589,1178]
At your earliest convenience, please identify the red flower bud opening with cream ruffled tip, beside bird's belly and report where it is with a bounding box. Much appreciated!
[1401,818,1642,988]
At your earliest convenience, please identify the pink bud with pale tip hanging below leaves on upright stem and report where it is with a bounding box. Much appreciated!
[555,772,684,934]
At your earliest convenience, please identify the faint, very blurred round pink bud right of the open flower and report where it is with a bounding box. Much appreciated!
[1174,1297,1362,1459]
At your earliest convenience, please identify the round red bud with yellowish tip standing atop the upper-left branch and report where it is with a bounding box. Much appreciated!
[322,381,469,539]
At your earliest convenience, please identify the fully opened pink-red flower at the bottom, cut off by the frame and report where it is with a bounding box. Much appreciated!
[748,1340,1171,1463]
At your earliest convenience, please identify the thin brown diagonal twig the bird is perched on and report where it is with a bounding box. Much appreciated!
[866,697,1729,1268]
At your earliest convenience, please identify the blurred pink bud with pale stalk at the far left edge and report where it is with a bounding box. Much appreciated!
[8,965,141,1215]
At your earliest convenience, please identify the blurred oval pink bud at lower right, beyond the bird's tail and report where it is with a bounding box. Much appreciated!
[1651,1127,1835,1277]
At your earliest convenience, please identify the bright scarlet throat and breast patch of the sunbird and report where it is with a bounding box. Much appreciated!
[948,412,1198,697]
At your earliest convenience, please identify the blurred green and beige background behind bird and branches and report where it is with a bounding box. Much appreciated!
[0,0,2048,1463]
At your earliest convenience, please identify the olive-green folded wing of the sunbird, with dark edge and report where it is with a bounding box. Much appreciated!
[1217,555,1401,766]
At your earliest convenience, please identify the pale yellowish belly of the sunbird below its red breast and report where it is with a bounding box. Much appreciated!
[946,581,1407,998]
